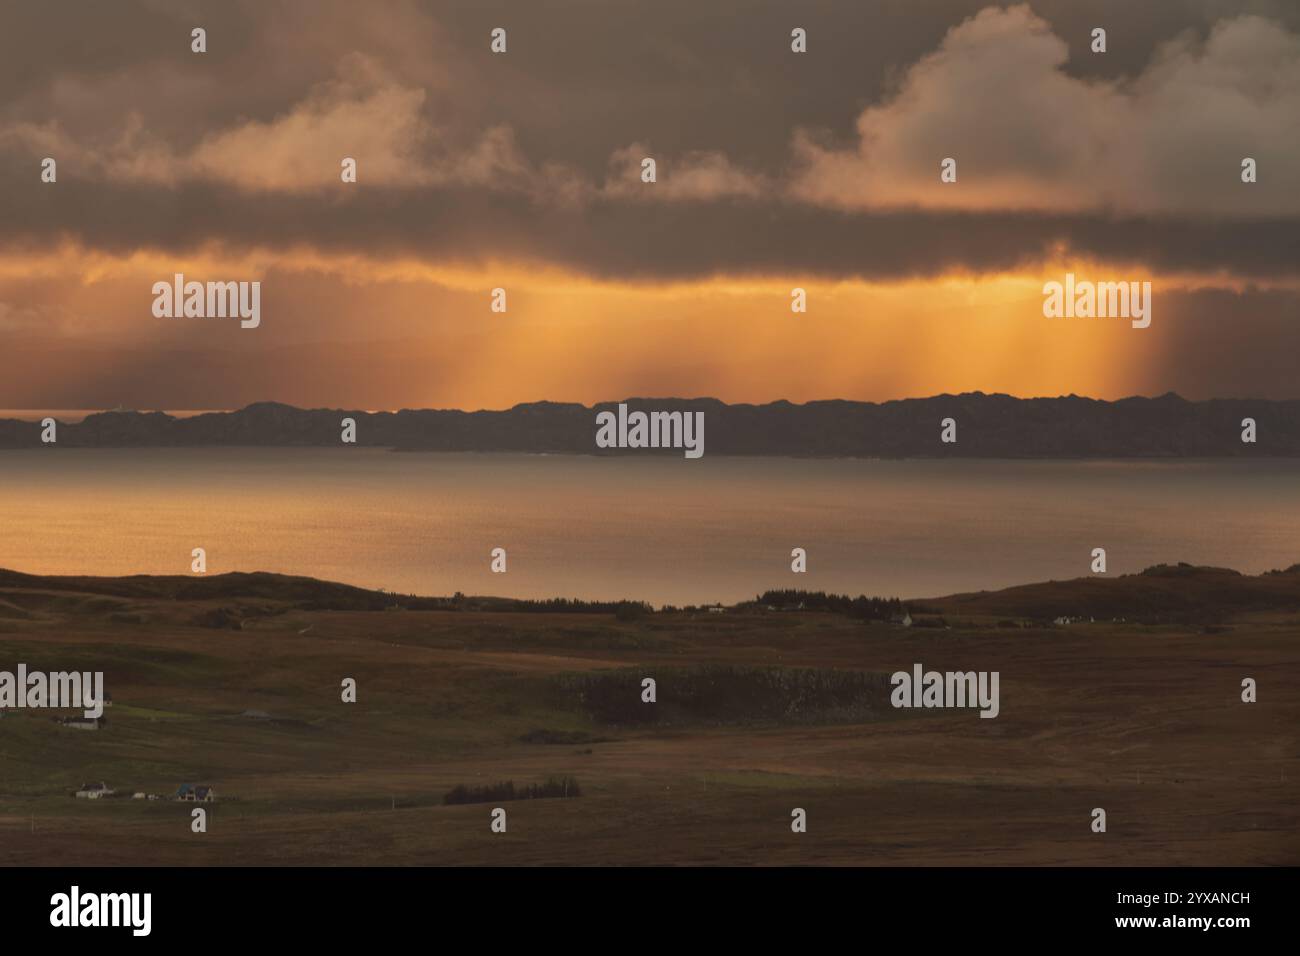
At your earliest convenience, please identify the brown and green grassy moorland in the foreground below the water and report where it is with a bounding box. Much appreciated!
[0,567,1300,865]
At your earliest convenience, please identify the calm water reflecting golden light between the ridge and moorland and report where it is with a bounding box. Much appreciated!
[0,447,1300,605]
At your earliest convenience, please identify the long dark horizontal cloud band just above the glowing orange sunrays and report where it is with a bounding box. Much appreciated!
[0,178,1300,280]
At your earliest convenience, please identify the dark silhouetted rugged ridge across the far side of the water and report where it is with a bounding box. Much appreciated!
[0,392,1300,458]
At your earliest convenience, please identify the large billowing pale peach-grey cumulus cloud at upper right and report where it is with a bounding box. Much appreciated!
[789,7,1300,215]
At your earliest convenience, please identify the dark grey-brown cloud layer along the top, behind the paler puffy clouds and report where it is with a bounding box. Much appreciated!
[0,0,1300,174]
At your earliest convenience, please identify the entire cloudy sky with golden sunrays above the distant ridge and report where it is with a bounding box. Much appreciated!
[0,0,1300,408]
